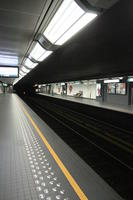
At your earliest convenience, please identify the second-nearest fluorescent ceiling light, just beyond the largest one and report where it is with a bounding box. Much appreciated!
[30,43,52,62]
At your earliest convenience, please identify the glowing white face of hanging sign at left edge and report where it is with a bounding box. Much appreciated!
[0,67,18,78]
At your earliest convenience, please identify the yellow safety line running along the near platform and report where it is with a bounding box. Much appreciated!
[22,105,88,200]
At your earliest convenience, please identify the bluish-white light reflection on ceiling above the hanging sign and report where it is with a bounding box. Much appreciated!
[0,55,18,66]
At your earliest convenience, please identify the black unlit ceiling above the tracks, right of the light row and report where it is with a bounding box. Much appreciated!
[16,0,133,90]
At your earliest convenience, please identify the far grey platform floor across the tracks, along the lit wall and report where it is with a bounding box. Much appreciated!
[39,93,133,114]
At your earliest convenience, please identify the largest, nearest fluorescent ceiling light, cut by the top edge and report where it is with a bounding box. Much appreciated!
[43,0,97,45]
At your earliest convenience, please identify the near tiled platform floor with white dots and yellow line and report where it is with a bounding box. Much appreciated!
[0,94,122,200]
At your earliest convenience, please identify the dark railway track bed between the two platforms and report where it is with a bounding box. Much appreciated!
[22,96,133,200]
